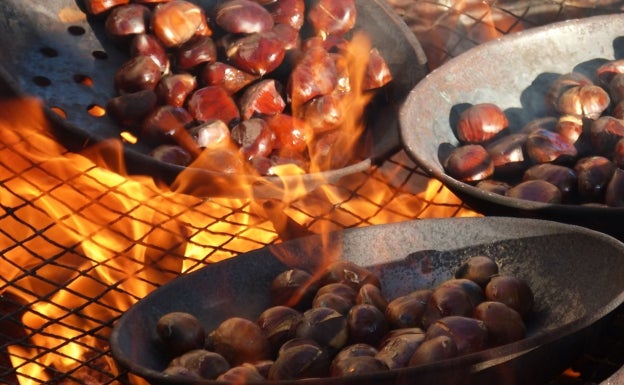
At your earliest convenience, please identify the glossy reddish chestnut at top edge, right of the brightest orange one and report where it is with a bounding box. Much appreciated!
[215,0,273,34]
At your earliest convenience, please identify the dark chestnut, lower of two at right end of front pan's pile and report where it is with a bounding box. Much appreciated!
[473,301,526,346]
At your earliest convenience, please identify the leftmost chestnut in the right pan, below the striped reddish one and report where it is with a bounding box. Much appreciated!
[443,144,494,182]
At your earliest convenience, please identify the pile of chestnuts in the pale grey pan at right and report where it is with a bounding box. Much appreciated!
[443,59,624,207]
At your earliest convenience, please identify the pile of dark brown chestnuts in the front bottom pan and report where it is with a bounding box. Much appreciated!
[156,255,534,383]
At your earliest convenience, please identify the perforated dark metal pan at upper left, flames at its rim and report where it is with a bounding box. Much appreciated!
[0,0,427,195]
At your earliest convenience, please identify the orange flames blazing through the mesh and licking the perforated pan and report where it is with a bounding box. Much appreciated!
[0,32,475,385]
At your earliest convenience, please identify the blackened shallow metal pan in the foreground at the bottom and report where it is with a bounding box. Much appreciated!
[110,217,624,385]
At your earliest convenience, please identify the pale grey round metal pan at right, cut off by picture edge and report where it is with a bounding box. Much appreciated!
[399,14,624,239]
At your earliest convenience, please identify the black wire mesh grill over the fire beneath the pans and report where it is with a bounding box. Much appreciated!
[0,0,624,384]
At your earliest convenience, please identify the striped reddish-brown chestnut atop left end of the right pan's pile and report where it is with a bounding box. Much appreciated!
[457,103,509,143]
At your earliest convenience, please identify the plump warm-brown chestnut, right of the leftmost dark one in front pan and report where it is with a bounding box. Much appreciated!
[213,317,271,366]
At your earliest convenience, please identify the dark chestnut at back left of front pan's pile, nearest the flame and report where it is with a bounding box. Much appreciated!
[270,269,319,310]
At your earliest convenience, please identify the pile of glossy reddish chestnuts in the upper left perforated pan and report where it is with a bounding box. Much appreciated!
[85,0,392,175]
